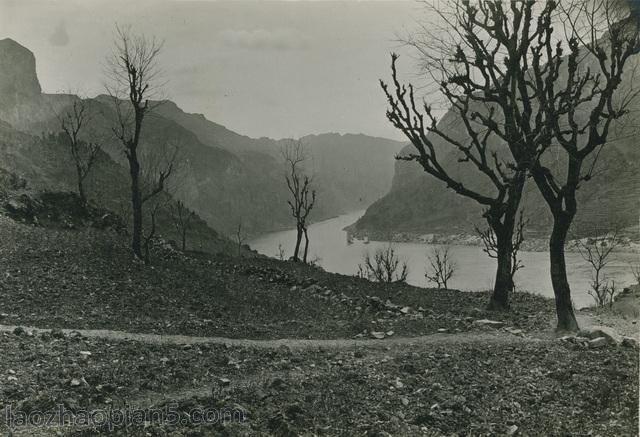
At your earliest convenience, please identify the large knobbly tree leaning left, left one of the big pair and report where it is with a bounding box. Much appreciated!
[380,52,526,310]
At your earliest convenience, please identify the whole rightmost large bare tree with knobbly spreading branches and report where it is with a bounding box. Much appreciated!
[398,0,640,331]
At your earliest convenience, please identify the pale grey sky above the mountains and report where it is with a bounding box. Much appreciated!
[0,0,436,139]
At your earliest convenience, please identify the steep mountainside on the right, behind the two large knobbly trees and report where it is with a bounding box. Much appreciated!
[350,51,640,239]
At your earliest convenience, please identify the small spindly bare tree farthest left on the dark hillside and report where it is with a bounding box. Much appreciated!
[57,99,100,204]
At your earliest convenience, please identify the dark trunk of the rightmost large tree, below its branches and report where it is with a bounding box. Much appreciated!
[549,213,578,332]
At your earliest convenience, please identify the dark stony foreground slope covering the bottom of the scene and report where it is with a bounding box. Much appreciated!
[0,218,638,436]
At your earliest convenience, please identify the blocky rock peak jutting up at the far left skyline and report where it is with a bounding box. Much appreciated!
[0,38,41,107]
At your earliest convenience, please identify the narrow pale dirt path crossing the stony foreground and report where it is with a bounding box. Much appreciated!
[0,325,547,349]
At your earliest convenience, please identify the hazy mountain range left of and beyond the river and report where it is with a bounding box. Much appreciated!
[0,39,401,235]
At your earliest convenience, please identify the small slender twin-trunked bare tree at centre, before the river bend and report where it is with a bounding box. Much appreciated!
[282,140,316,263]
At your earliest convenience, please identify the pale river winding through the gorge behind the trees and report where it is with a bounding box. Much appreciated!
[249,211,639,308]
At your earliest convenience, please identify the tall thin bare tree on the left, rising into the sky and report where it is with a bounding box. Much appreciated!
[107,26,165,258]
